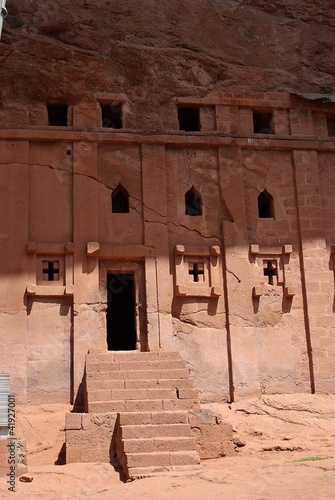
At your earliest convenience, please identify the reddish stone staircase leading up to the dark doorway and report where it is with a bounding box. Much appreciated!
[86,351,200,478]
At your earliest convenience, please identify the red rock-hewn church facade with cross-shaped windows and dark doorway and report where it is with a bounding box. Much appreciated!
[0,92,335,408]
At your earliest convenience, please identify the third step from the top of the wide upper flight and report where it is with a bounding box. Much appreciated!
[86,368,189,381]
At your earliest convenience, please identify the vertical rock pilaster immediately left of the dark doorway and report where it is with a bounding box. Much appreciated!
[73,141,100,405]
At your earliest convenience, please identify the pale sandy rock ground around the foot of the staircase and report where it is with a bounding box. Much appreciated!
[0,395,335,500]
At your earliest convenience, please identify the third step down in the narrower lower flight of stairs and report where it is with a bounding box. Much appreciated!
[123,437,195,453]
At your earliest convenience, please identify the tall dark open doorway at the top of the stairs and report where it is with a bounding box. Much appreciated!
[107,274,136,351]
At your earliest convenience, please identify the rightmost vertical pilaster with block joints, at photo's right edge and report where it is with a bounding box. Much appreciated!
[293,151,335,392]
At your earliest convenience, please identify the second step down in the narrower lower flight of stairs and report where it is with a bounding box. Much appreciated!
[121,424,192,440]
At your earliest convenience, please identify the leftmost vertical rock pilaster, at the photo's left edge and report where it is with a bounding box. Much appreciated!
[0,140,29,403]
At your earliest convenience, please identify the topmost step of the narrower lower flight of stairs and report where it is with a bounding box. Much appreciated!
[119,410,189,425]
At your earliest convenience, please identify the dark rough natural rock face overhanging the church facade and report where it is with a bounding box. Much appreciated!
[0,0,335,108]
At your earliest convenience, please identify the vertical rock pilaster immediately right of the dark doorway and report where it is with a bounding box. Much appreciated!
[142,145,173,351]
